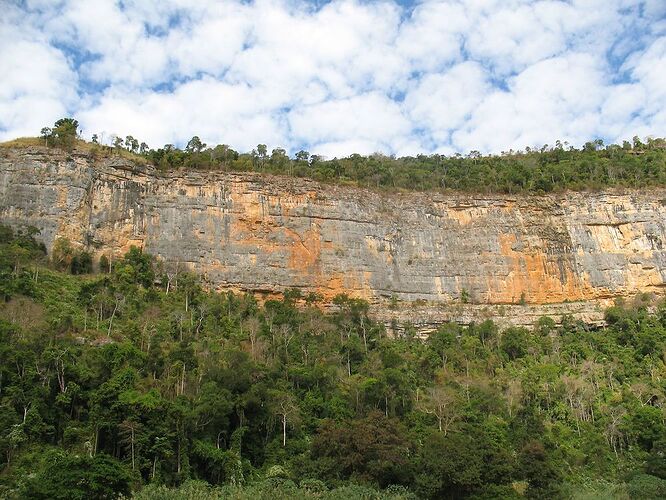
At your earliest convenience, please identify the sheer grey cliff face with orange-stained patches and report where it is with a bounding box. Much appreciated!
[0,147,666,329]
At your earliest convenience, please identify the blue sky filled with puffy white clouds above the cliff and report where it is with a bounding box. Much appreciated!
[0,0,666,158]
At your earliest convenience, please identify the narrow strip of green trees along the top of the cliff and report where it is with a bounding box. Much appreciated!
[6,118,666,193]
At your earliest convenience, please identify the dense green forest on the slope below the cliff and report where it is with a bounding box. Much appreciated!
[0,226,666,500]
